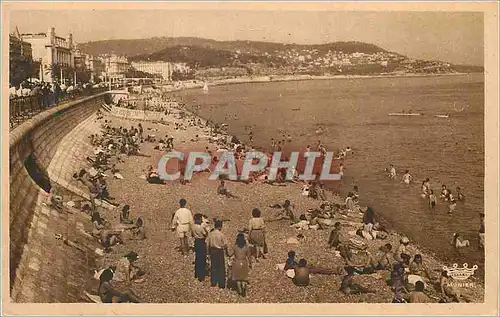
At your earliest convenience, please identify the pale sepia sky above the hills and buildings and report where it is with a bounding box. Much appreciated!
[9,9,484,66]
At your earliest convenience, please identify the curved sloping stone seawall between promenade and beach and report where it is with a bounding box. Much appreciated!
[9,93,108,302]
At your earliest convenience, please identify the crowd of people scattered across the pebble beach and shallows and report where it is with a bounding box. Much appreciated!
[44,86,484,303]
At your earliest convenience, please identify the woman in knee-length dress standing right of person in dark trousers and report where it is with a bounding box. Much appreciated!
[231,233,252,297]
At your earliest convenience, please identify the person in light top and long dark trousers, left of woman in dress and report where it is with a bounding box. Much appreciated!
[206,220,227,289]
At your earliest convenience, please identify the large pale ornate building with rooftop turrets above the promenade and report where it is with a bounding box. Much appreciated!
[21,27,75,82]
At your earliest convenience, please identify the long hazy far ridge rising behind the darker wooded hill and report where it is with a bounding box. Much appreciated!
[78,37,385,57]
